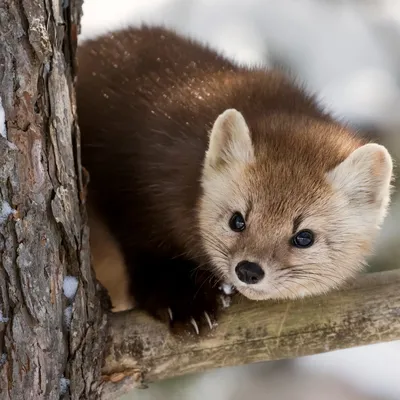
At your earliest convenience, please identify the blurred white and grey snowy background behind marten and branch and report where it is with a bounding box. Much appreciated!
[80,0,400,400]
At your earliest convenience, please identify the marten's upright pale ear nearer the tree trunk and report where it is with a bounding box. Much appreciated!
[205,109,254,168]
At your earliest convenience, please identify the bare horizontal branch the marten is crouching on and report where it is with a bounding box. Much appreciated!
[99,270,400,399]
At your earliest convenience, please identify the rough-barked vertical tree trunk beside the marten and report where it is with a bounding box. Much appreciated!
[0,0,106,400]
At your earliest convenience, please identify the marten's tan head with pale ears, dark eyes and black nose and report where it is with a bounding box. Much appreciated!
[199,109,392,300]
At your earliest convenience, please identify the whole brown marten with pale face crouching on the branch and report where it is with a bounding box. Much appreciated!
[77,26,392,332]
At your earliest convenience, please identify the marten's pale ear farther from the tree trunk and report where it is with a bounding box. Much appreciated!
[328,143,393,224]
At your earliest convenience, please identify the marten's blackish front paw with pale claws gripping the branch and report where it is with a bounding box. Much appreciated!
[132,256,227,334]
